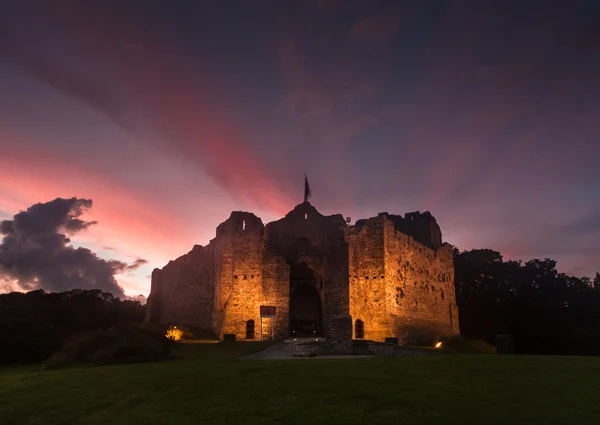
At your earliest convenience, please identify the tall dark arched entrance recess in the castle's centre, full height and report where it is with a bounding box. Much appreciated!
[290,263,323,337]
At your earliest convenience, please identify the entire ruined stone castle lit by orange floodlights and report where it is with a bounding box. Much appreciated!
[146,201,459,343]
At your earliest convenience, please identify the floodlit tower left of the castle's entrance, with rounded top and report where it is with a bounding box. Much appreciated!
[213,212,264,339]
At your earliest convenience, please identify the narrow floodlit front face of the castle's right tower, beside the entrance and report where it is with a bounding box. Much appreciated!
[346,217,392,341]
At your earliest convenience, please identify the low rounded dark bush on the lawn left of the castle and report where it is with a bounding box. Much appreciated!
[46,324,172,369]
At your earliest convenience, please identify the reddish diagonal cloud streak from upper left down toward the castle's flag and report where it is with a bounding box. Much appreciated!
[3,0,293,214]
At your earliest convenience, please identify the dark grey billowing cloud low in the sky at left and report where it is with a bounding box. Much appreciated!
[0,198,134,297]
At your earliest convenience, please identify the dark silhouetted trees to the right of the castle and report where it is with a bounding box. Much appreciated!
[454,249,600,354]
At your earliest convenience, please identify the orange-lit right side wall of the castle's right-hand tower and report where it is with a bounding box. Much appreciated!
[383,219,459,343]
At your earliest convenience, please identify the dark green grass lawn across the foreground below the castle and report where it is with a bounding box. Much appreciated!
[0,343,600,425]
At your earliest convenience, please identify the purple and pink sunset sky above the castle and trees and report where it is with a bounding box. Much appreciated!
[0,0,600,295]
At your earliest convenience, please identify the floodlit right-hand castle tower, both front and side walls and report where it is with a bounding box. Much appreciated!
[347,213,459,343]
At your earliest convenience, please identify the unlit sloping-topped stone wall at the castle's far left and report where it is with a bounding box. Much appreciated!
[147,244,214,330]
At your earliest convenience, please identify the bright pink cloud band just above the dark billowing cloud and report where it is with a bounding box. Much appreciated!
[0,129,197,293]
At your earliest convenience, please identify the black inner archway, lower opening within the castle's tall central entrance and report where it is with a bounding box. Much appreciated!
[290,284,323,337]
